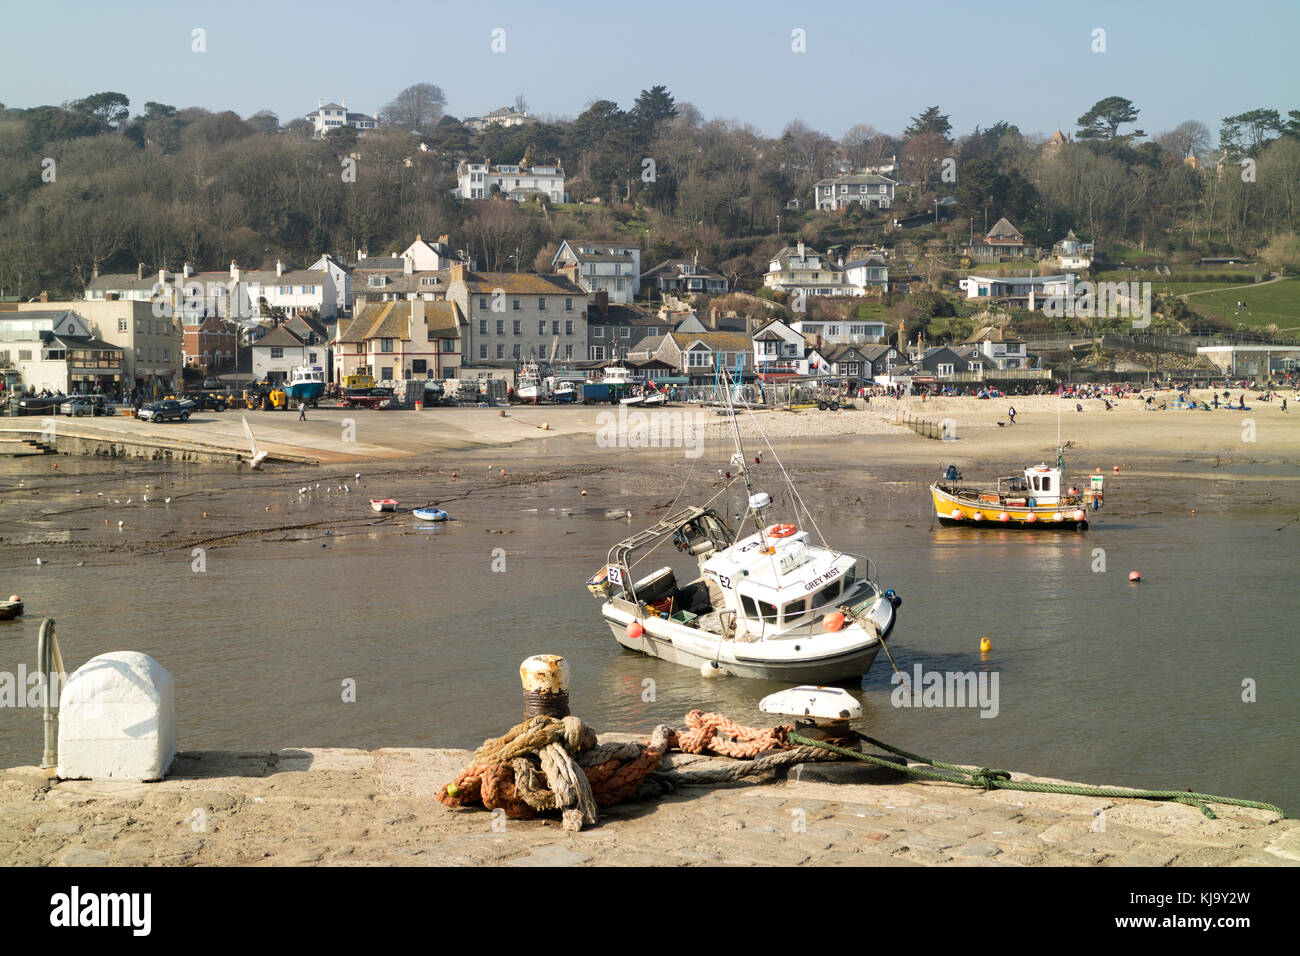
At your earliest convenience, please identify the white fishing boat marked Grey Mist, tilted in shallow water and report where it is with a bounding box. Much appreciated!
[588,377,901,684]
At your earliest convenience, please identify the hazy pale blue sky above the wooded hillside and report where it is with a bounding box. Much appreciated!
[0,0,1300,138]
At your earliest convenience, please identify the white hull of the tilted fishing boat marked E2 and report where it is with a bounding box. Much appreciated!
[602,598,894,684]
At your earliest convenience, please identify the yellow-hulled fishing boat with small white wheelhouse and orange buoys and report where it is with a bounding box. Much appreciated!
[930,464,1102,531]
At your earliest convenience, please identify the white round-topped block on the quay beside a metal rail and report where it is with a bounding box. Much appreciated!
[59,650,176,780]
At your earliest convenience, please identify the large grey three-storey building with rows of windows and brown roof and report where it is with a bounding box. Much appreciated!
[447,265,588,364]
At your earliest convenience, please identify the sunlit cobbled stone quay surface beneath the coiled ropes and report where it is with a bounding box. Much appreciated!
[0,735,1300,866]
